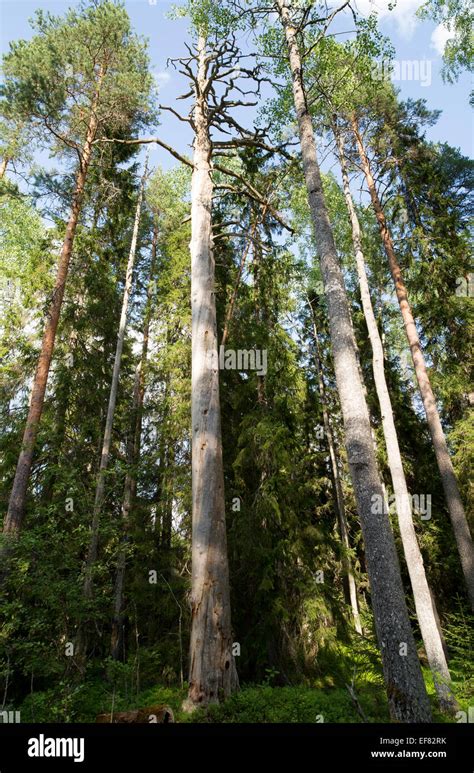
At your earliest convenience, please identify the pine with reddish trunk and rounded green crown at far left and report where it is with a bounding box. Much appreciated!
[3,2,150,548]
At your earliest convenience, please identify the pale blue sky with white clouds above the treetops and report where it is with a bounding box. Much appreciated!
[0,0,473,175]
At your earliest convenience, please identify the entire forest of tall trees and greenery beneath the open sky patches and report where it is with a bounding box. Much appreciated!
[0,0,474,722]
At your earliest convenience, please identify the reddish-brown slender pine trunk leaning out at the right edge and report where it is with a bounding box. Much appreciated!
[351,116,474,610]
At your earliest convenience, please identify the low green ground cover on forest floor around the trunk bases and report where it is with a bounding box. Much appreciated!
[16,664,473,723]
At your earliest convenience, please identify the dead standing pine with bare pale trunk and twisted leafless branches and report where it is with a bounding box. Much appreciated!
[163,28,292,710]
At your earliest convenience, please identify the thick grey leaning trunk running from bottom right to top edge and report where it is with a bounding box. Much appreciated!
[277,0,431,722]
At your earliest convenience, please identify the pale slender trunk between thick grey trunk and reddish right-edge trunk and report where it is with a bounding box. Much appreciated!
[333,119,457,711]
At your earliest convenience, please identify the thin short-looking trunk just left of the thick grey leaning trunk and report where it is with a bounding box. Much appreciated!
[308,298,362,634]
